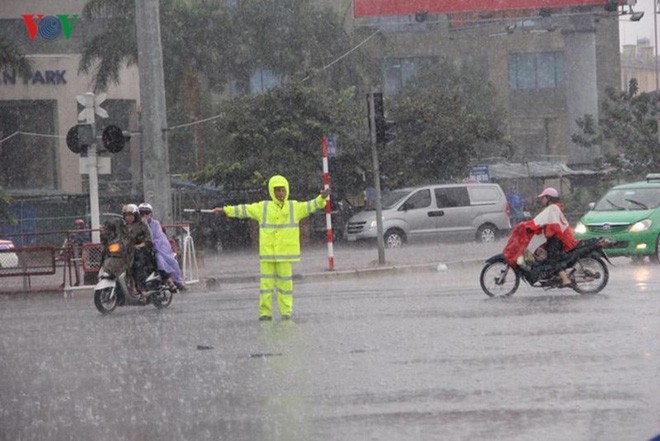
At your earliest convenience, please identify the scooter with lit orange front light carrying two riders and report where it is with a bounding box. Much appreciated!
[94,220,176,314]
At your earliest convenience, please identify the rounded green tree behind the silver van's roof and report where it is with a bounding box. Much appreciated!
[380,60,509,187]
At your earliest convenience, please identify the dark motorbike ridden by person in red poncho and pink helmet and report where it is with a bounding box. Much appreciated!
[479,224,611,297]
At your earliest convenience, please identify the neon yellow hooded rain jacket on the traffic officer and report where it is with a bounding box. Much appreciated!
[223,175,326,262]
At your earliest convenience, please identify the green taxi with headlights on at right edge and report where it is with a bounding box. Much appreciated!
[574,173,660,262]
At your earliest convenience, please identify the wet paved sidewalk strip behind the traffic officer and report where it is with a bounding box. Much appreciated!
[198,240,506,287]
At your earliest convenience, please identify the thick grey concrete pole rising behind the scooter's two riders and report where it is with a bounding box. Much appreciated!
[135,0,173,223]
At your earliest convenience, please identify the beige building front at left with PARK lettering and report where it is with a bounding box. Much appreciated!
[0,0,140,196]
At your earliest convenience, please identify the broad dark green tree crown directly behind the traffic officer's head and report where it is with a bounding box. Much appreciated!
[194,83,366,197]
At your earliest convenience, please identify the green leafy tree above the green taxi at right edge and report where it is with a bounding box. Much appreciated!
[572,79,660,179]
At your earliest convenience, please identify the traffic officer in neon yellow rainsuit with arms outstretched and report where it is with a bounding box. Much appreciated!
[213,175,330,320]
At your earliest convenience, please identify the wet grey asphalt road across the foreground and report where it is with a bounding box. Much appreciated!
[0,262,660,441]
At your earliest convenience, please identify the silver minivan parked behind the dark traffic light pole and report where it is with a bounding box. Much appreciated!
[346,180,511,248]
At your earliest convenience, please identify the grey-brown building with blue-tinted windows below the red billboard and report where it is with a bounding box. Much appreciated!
[349,2,620,167]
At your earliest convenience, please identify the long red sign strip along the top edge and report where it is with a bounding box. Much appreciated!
[353,0,604,18]
